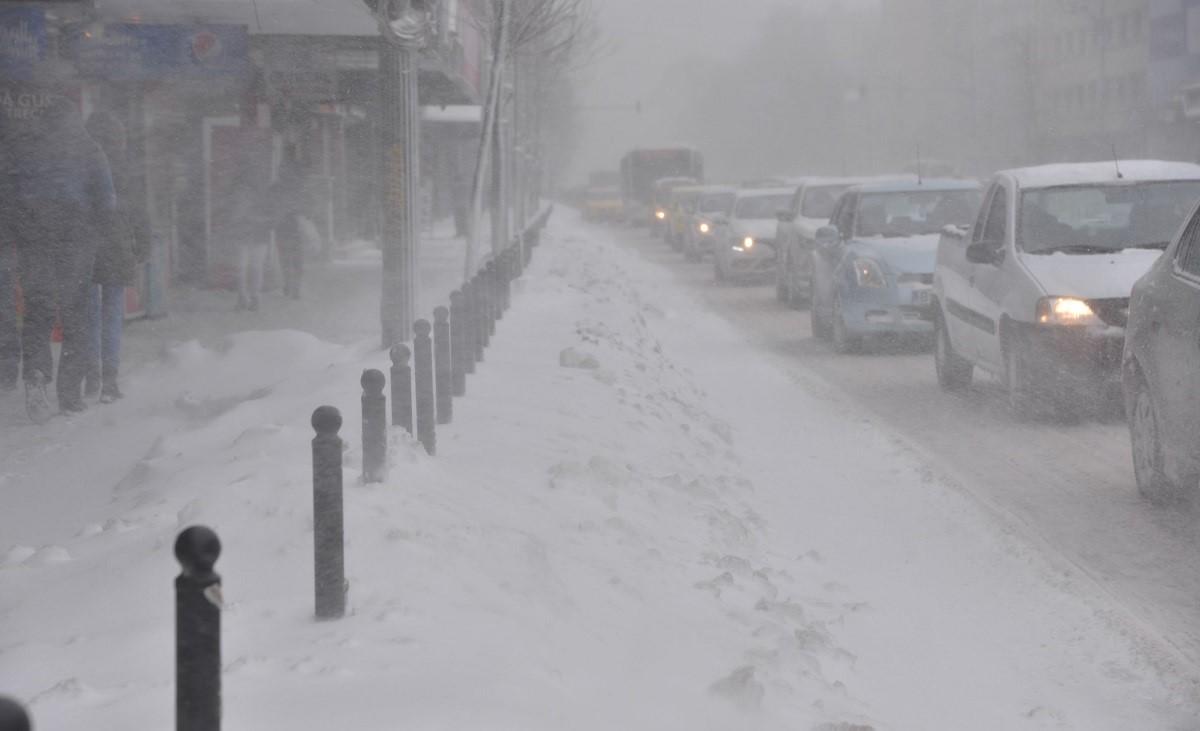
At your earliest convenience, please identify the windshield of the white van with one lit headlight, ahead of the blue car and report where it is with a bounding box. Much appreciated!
[1018,180,1200,253]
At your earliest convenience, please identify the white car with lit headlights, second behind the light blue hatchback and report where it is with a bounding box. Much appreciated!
[713,187,792,282]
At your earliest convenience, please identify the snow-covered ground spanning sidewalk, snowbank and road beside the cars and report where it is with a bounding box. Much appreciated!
[0,210,1200,731]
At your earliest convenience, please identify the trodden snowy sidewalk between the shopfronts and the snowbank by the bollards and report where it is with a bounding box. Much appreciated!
[0,227,477,549]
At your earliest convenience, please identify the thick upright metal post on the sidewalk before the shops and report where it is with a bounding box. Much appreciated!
[365,0,437,348]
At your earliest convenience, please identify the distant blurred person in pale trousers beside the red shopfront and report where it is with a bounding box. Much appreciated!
[229,155,275,312]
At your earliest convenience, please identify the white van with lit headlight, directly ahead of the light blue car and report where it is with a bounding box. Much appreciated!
[934,161,1200,417]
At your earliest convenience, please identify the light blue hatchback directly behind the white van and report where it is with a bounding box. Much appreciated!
[811,179,982,353]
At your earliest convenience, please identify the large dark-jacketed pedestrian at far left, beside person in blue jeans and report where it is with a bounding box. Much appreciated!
[0,91,116,421]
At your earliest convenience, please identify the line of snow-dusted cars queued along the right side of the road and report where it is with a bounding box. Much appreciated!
[580,160,1200,502]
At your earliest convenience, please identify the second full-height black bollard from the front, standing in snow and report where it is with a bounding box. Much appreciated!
[312,406,346,619]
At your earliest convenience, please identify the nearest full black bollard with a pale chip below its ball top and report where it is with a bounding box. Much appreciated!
[175,526,221,731]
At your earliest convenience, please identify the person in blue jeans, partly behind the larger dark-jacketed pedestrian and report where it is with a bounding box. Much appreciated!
[84,112,150,403]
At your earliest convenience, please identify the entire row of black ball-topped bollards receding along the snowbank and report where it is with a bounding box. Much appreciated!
[0,209,551,731]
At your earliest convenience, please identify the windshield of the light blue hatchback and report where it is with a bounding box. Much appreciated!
[856,190,980,238]
